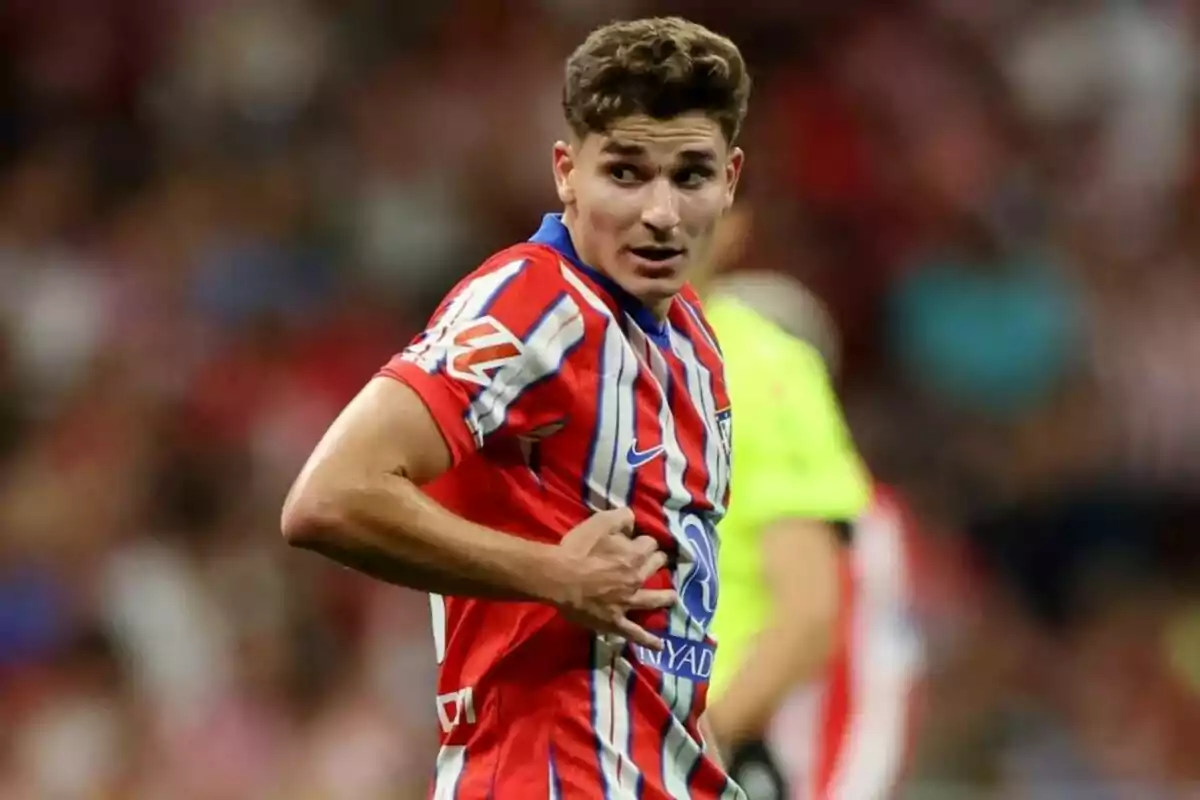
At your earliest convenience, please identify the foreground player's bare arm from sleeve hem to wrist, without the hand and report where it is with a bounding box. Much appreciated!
[282,378,559,602]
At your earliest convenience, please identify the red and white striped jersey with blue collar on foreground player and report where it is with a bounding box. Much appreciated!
[383,215,744,800]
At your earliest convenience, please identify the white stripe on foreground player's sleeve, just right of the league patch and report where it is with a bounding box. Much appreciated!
[468,296,584,443]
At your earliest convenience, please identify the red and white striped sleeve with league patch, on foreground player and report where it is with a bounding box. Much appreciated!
[380,258,586,463]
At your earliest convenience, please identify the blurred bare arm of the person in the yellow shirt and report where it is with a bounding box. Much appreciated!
[707,519,841,752]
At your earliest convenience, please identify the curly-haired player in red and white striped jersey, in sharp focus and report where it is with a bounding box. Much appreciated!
[283,18,750,800]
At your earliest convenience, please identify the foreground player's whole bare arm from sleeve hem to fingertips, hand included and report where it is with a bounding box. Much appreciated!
[281,378,674,649]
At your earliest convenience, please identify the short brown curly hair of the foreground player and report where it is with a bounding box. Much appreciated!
[563,17,750,144]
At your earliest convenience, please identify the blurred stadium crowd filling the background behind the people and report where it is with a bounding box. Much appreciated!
[0,0,1200,800]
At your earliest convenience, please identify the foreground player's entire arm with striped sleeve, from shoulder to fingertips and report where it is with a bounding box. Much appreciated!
[282,261,674,649]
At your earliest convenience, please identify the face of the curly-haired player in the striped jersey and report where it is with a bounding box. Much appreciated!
[554,114,743,314]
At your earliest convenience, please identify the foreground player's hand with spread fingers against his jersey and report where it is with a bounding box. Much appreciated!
[553,509,676,650]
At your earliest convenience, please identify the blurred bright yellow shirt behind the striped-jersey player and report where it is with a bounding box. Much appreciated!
[704,296,870,697]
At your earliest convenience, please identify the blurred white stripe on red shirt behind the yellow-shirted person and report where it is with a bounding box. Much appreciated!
[830,510,920,800]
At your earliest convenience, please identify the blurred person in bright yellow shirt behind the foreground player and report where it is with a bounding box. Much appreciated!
[700,212,870,800]
